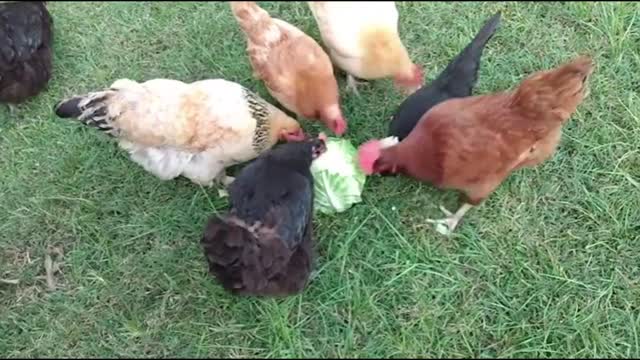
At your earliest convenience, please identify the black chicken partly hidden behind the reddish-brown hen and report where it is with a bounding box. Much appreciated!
[389,13,500,140]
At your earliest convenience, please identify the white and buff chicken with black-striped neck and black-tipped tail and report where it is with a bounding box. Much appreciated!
[54,79,304,186]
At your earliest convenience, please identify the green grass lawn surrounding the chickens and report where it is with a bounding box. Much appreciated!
[0,2,640,358]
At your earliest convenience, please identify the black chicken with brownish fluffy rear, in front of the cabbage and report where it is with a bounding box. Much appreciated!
[200,134,326,296]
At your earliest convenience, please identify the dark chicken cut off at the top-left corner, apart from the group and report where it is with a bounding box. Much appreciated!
[0,1,53,108]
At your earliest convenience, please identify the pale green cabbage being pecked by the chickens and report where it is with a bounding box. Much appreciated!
[311,138,367,214]
